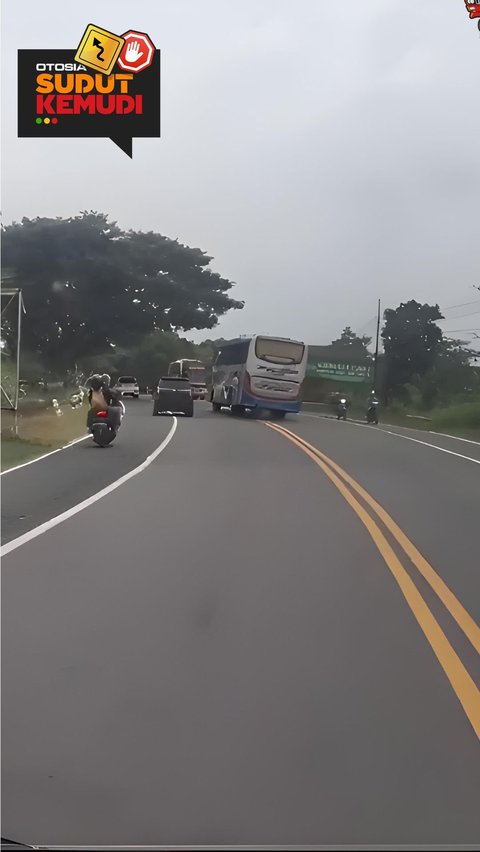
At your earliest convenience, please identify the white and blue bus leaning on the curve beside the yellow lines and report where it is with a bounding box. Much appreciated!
[210,335,308,418]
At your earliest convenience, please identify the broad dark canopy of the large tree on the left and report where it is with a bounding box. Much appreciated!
[2,211,243,365]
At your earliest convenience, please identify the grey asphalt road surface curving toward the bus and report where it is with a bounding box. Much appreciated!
[2,401,480,848]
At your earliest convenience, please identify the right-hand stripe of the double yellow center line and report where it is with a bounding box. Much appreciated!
[270,426,480,654]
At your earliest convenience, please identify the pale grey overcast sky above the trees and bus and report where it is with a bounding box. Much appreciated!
[2,0,480,343]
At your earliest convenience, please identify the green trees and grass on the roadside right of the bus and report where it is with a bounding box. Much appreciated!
[304,298,480,440]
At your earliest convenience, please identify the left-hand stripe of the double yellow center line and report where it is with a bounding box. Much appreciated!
[265,423,480,739]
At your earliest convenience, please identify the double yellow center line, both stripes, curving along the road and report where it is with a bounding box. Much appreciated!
[265,423,480,738]
